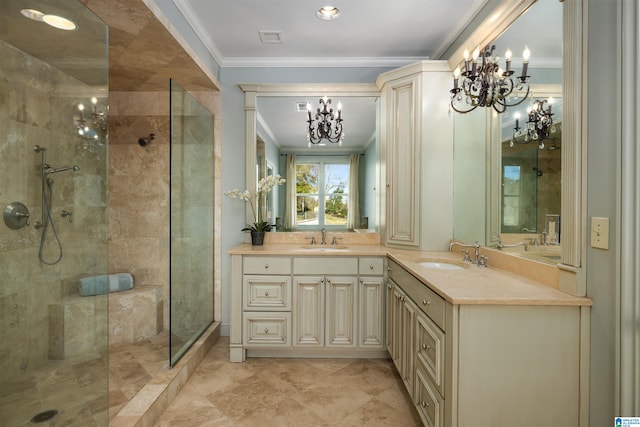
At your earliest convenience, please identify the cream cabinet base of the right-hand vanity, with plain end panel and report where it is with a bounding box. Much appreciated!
[386,260,589,427]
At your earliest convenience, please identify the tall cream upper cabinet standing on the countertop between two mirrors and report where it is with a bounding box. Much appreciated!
[376,61,453,250]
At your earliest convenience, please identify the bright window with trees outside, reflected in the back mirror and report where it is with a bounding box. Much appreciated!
[296,158,349,229]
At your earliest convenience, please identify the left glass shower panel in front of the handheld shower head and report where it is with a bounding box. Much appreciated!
[0,0,109,426]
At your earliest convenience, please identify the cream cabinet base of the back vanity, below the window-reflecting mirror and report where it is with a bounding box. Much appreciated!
[230,255,386,362]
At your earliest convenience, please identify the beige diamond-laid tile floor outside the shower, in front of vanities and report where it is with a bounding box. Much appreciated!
[156,337,422,427]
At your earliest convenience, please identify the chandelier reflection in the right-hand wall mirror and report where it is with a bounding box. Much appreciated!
[509,98,556,150]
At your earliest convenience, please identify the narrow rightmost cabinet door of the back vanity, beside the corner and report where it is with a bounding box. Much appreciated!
[359,277,384,348]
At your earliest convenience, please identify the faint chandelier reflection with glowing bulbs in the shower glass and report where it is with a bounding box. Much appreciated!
[73,96,107,160]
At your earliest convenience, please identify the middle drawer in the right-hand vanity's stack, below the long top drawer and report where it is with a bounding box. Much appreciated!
[416,312,445,395]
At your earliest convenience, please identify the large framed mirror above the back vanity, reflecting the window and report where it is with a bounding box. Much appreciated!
[241,85,380,232]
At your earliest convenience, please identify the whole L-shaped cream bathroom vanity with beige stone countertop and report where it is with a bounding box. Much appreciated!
[230,244,591,427]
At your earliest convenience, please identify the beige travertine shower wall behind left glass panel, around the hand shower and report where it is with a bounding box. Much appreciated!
[0,38,107,380]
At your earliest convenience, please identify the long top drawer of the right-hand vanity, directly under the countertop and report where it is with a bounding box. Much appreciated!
[389,260,446,331]
